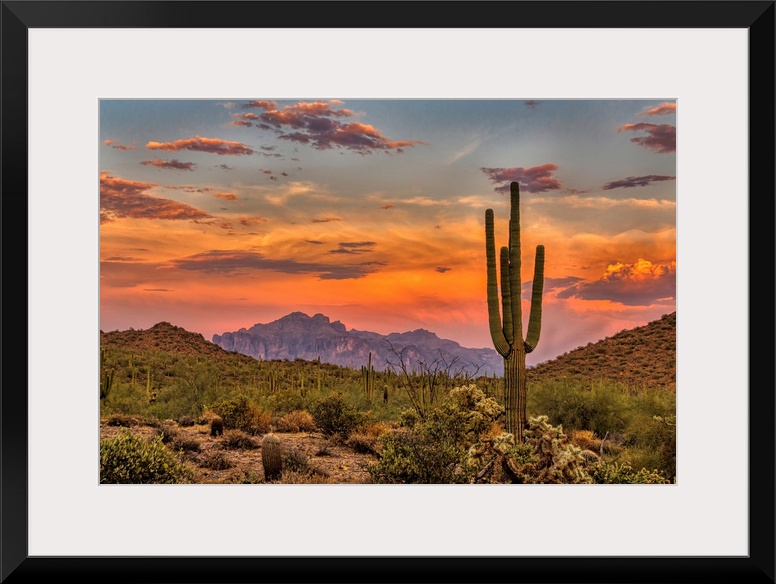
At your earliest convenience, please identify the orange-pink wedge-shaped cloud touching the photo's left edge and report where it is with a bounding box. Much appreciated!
[100,172,211,223]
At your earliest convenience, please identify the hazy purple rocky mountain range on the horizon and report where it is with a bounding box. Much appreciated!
[213,312,504,376]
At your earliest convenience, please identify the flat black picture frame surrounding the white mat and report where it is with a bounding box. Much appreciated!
[0,0,776,584]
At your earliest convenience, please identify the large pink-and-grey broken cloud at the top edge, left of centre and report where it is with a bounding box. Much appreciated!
[239,100,425,154]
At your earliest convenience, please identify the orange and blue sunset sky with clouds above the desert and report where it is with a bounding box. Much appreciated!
[99,97,676,365]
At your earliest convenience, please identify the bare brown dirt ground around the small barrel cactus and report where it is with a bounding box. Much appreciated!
[100,420,377,484]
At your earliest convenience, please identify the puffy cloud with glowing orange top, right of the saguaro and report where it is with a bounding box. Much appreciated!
[558,259,676,306]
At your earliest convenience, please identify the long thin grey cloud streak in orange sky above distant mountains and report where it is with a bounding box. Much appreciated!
[169,250,385,280]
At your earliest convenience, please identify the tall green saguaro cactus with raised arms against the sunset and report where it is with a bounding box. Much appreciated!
[485,182,544,442]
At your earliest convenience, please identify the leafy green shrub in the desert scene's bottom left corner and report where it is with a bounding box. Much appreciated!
[100,430,193,484]
